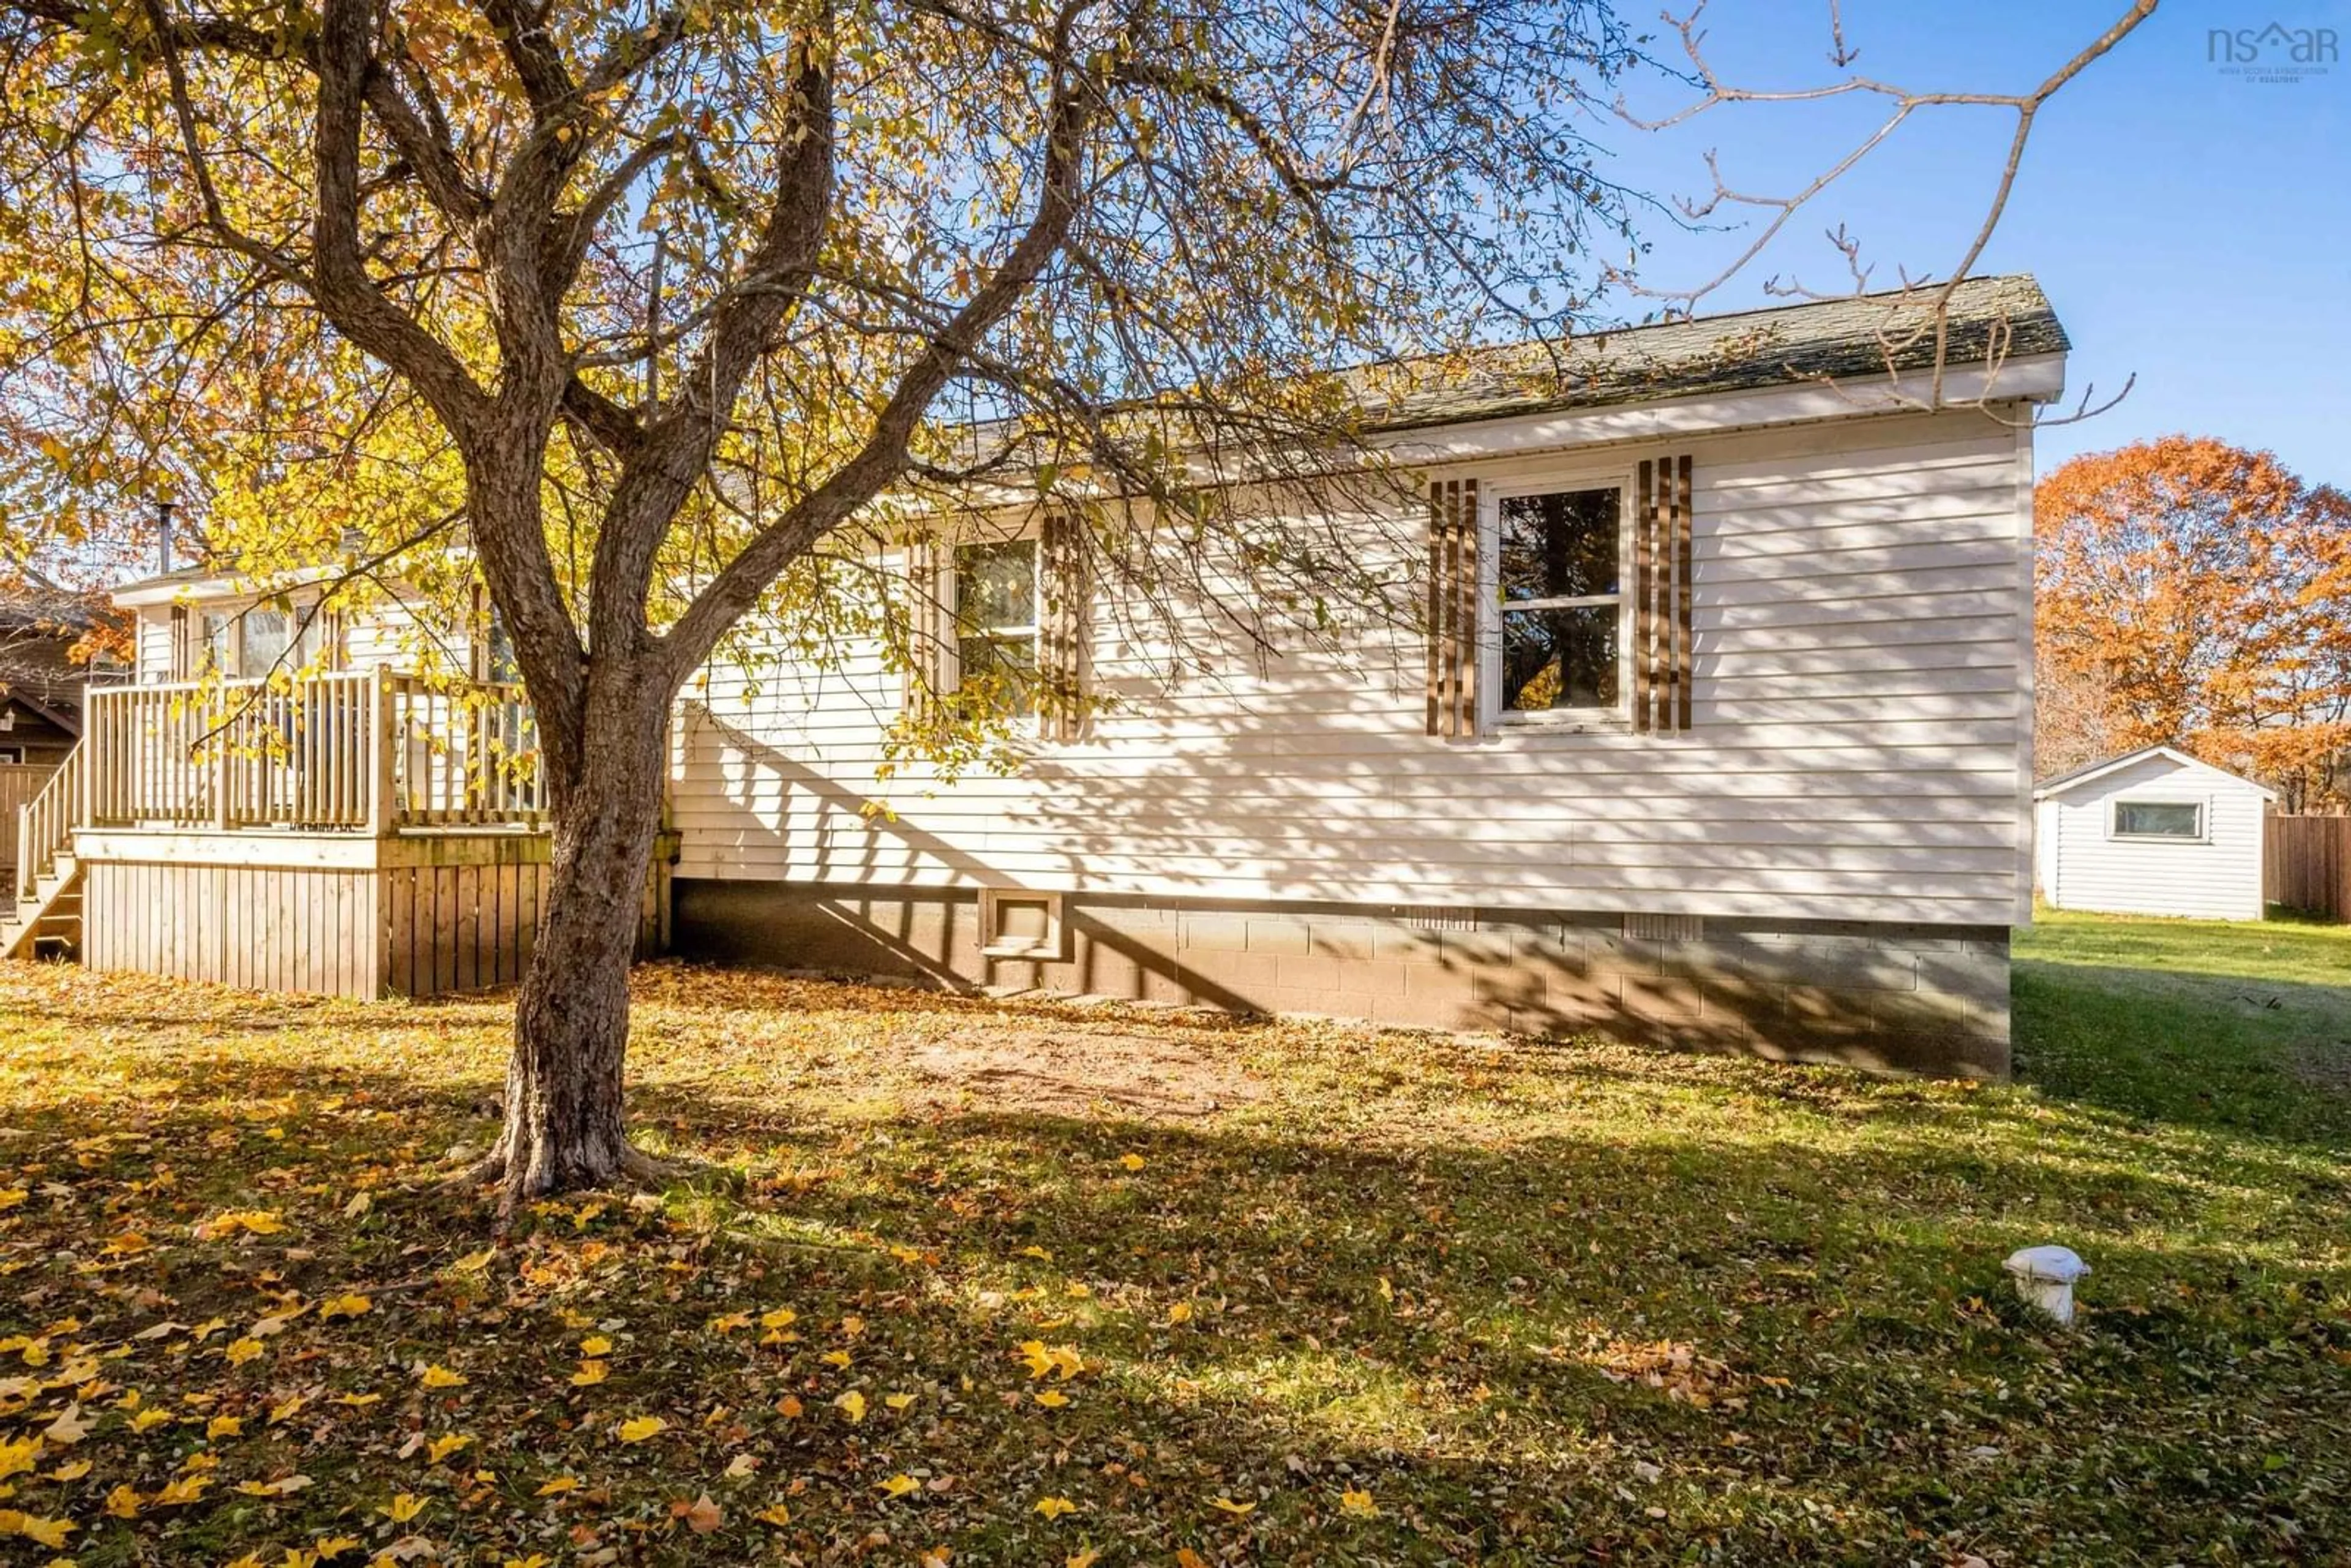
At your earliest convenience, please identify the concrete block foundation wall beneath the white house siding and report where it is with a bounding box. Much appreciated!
[672,879,2008,1079]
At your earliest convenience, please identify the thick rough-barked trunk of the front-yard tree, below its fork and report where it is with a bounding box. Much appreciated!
[484,694,668,1210]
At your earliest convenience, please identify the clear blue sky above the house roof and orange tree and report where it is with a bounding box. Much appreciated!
[1599,0,2351,484]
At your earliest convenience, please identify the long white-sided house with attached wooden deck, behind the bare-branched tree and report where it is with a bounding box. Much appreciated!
[13,277,2066,1075]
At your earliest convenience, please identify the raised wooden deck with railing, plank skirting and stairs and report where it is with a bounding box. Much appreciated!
[0,670,668,997]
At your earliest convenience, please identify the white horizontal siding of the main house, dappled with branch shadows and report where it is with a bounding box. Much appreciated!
[672,414,2029,924]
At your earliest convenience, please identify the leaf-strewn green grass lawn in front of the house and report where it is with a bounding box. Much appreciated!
[0,917,2351,1568]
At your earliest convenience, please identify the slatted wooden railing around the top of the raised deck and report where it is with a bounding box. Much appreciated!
[82,670,543,835]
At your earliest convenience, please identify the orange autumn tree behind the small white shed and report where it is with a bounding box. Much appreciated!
[2034,435,2351,811]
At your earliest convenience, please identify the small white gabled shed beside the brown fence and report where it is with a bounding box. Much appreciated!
[2034,745,2278,919]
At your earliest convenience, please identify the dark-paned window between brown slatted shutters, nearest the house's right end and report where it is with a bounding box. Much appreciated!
[1493,487,1624,715]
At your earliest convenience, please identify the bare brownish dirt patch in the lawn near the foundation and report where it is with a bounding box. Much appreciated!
[907,1027,1265,1121]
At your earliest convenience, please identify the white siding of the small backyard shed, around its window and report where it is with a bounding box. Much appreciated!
[2041,757,2264,919]
